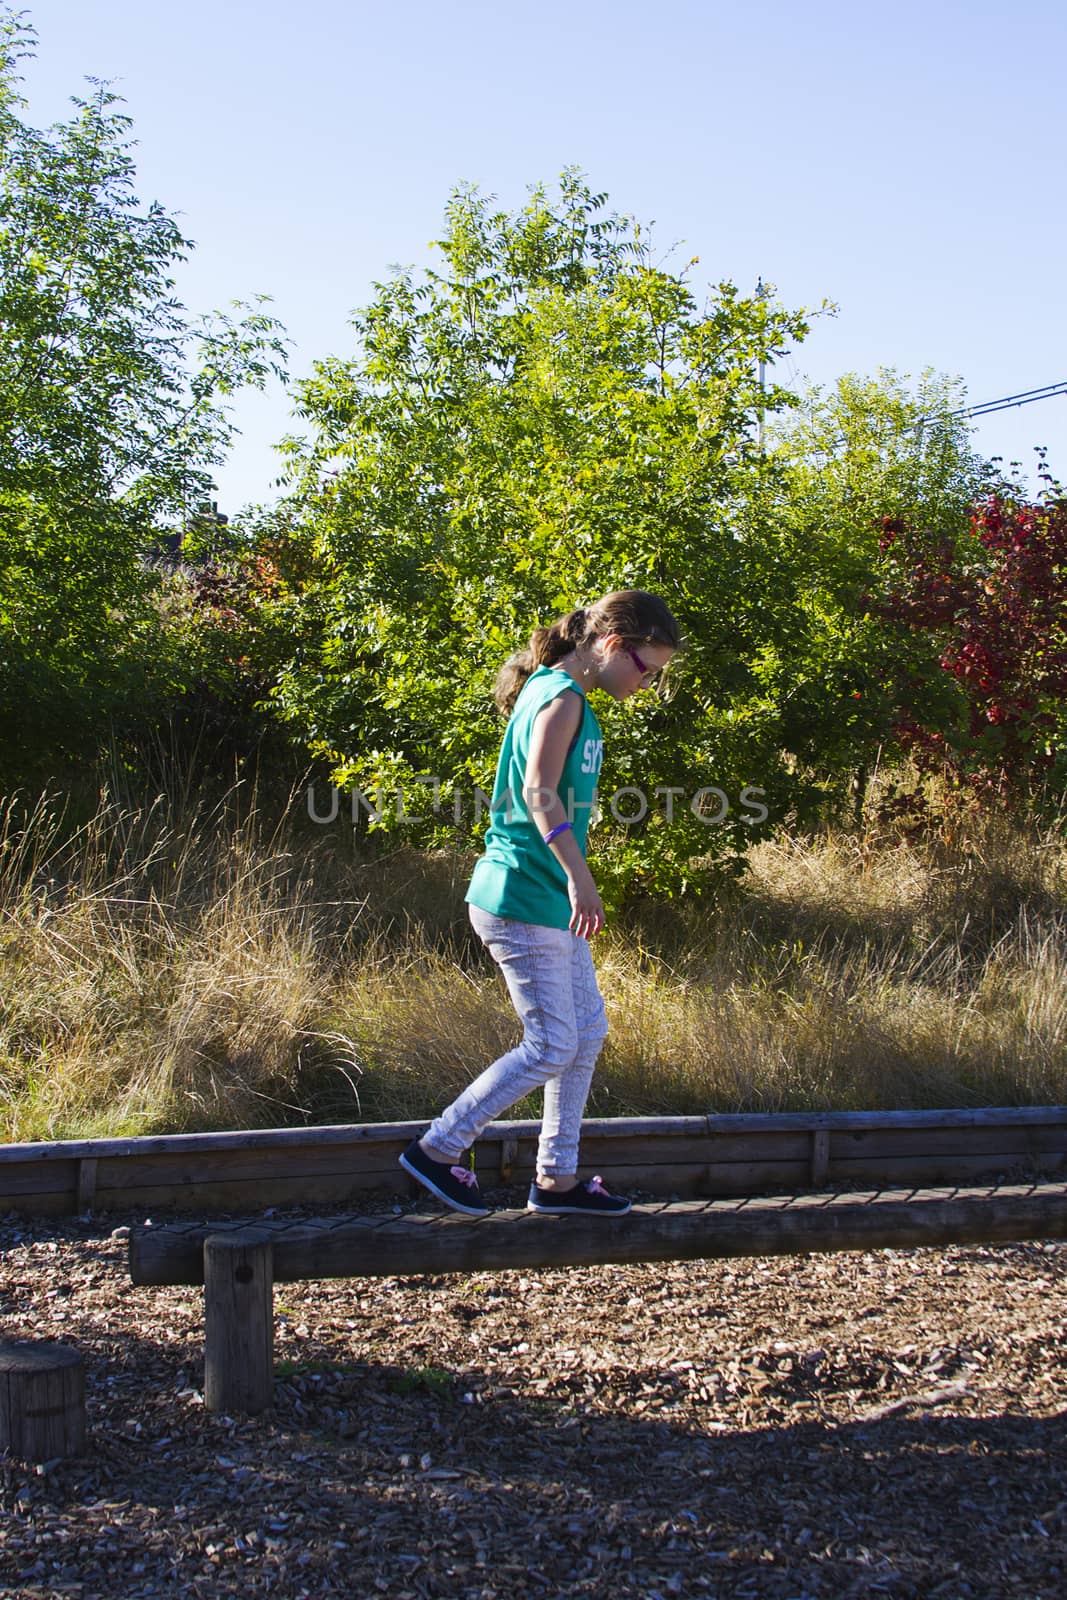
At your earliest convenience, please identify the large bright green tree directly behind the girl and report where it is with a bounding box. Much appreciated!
[278,171,806,888]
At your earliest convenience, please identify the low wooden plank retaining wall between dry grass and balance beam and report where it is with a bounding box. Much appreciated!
[0,1106,1067,1216]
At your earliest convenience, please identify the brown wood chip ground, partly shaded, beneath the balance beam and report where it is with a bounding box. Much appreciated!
[0,1197,1067,1600]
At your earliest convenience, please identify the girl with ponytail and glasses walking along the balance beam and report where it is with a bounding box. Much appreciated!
[400,589,680,1216]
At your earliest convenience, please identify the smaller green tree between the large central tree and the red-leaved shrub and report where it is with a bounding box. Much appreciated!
[763,368,993,806]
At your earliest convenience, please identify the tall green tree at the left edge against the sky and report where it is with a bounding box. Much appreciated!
[0,11,283,781]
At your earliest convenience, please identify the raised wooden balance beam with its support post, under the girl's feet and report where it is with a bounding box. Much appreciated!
[130,1182,1067,1413]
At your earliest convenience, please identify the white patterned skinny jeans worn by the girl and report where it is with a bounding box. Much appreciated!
[424,906,608,1178]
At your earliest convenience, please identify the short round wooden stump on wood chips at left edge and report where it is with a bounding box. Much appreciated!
[0,1341,85,1461]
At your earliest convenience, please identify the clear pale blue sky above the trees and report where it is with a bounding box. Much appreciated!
[24,0,1067,512]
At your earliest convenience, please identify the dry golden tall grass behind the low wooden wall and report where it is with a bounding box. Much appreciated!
[0,790,1067,1141]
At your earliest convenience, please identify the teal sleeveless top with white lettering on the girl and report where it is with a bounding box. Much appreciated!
[467,667,603,928]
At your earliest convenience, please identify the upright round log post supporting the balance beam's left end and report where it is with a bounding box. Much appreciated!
[203,1229,274,1413]
